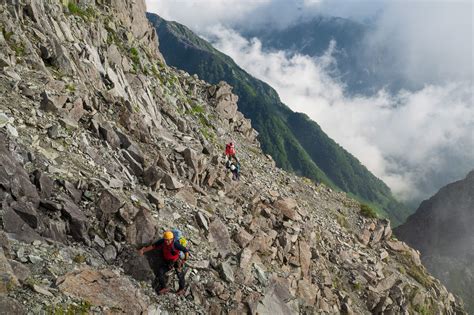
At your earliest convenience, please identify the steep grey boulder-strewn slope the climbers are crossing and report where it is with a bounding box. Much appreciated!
[0,0,463,314]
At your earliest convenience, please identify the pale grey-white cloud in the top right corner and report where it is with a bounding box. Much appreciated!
[364,1,474,86]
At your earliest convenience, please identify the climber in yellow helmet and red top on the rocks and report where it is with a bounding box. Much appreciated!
[138,231,188,295]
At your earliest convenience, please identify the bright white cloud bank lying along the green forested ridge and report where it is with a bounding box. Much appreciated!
[209,27,474,204]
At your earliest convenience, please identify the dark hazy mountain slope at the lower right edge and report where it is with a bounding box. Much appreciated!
[396,171,474,314]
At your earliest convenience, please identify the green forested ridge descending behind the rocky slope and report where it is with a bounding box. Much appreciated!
[147,13,408,225]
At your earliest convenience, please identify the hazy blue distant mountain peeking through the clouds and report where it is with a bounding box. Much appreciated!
[242,16,409,95]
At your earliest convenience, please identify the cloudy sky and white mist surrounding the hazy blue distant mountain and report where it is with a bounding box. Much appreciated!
[147,0,474,199]
